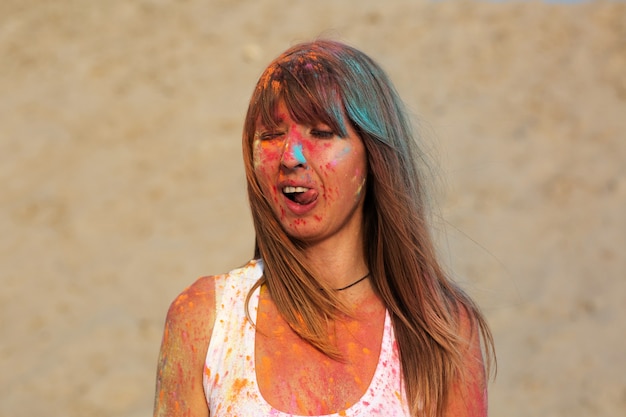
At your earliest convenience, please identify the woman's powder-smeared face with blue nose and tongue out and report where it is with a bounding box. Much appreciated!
[253,102,367,243]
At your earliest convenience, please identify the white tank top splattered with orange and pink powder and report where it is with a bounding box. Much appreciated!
[203,260,410,417]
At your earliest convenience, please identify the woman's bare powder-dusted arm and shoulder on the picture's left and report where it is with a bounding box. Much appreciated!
[154,277,215,417]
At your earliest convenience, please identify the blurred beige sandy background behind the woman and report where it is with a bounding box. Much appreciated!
[0,0,626,417]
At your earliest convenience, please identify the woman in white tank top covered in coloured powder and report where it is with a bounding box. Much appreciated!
[154,40,493,417]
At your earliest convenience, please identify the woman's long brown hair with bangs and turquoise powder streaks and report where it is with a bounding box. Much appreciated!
[243,40,494,416]
